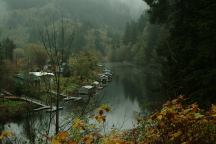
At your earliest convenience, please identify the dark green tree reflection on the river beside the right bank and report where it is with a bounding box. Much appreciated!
[117,66,166,111]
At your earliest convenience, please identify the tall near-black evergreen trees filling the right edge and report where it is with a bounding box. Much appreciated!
[145,0,216,106]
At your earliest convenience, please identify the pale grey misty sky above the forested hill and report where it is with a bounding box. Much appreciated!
[0,0,148,31]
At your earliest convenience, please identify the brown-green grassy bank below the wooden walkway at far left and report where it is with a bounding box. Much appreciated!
[0,99,37,123]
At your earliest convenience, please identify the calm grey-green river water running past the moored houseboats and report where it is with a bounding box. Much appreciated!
[1,64,164,141]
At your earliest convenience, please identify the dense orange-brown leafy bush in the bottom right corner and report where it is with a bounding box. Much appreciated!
[142,97,216,144]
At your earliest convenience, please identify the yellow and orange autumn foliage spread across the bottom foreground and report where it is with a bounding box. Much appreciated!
[0,96,216,144]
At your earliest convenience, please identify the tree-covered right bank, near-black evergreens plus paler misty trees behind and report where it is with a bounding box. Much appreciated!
[113,0,216,106]
